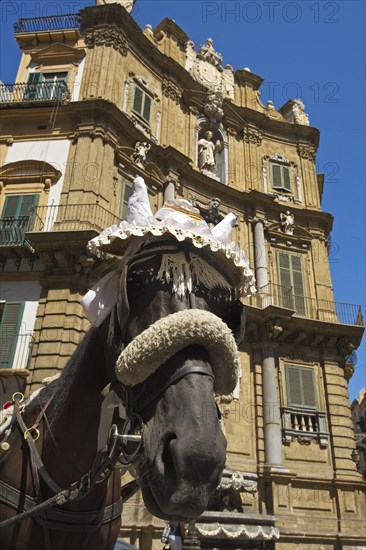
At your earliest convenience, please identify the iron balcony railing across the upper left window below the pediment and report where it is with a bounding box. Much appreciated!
[0,80,70,104]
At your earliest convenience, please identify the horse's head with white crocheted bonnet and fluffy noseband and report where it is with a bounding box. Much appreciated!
[84,178,254,520]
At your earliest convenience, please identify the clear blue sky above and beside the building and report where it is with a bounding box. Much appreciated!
[0,0,366,401]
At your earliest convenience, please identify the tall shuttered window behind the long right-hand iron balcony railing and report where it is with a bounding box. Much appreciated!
[277,251,306,317]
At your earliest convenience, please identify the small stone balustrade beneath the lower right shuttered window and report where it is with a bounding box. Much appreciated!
[282,407,329,447]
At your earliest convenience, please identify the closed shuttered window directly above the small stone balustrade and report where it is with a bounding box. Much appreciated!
[285,365,317,409]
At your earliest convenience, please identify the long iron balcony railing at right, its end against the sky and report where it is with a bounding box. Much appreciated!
[249,284,364,327]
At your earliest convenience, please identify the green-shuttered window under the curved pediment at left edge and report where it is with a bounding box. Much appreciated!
[0,194,39,244]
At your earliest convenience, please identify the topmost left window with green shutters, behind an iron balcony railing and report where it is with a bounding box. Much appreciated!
[24,72,68,100]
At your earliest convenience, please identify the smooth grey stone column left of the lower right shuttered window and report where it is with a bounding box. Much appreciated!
[262,340,282,469]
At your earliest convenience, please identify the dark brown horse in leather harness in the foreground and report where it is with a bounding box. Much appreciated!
[0,244,243,550]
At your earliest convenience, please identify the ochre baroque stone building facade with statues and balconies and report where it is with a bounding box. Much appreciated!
[0,0,366,550]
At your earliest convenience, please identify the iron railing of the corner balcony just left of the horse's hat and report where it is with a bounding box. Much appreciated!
[29,203,121,235]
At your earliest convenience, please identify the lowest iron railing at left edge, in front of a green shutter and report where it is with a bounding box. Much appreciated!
[0,330,34,369]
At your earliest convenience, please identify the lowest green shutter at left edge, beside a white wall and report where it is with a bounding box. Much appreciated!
[0,302,24,369]
